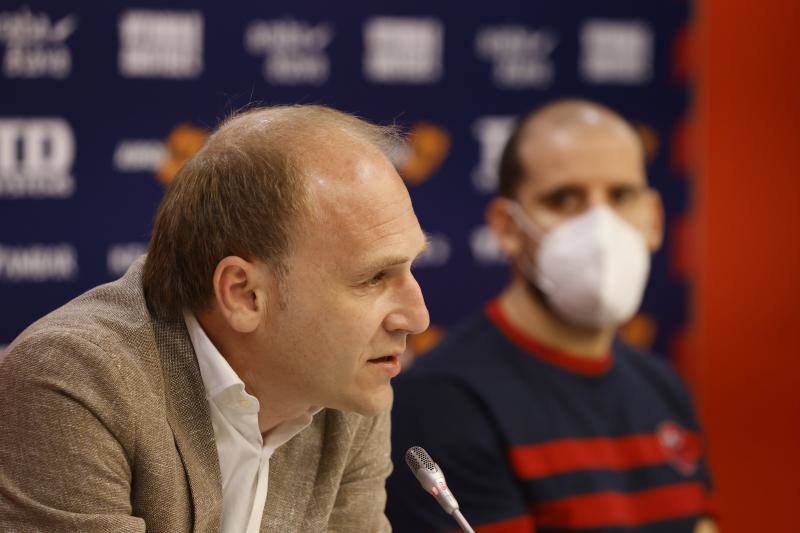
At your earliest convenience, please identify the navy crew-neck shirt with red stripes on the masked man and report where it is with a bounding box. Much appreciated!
[387,302,711,533]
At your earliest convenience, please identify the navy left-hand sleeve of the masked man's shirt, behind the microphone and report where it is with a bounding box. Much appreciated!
[387,376,534,533]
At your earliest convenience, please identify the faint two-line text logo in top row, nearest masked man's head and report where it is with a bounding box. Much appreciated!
[475,25,557,89]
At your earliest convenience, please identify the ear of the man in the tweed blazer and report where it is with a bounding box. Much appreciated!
[213,255,267,333]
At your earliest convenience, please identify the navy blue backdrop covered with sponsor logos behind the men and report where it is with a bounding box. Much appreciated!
[0,0,690,362]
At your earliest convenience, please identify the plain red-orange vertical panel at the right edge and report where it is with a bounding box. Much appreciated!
[695,0,800,533]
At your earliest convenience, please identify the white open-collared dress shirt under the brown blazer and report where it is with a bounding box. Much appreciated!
[184,312,320,533]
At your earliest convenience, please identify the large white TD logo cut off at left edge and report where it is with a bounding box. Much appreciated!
[0,118,75,198]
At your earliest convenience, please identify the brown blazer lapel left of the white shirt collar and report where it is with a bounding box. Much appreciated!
[154,319,222,533]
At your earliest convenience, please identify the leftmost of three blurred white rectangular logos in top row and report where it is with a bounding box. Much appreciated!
[118,9,204,79]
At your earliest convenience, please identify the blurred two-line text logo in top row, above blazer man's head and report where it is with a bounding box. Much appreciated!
[244,18,333,85]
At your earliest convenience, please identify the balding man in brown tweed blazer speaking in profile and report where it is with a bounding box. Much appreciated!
[0,106,428,533]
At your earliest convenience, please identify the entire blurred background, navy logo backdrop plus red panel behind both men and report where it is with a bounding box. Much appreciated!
[0,0,800,532]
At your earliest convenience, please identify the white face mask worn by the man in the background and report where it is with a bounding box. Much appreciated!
[510,203,650,328]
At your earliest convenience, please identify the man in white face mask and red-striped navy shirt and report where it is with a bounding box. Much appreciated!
[387,100,716,533]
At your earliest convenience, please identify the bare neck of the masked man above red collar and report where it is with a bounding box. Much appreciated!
[499,275,616,359]
